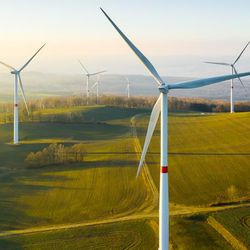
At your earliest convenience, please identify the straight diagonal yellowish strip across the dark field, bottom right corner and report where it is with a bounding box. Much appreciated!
[207,216,247,250]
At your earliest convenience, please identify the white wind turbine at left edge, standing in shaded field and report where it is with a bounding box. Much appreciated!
[0,44,45,144]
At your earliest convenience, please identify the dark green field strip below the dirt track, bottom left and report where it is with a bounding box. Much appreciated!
[0,221,158,250]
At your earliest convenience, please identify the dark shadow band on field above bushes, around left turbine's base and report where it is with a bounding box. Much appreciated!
[0,122,133,169]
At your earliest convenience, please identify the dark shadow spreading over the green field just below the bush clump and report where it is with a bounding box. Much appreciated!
[0,160,138,232]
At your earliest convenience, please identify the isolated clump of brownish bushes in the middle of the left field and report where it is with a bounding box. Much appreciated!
[25,143,85,167]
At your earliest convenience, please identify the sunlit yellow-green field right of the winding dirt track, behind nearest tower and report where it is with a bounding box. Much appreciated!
[138,113,250,205]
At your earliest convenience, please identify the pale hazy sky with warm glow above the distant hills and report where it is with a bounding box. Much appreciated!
[0,0,250,77]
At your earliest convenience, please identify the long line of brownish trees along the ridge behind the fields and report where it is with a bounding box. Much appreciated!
[0,95,250,123]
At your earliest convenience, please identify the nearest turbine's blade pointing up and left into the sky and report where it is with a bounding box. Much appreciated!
[101,8,164,85]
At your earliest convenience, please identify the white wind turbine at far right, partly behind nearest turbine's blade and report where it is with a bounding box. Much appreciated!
[205,42,250,113]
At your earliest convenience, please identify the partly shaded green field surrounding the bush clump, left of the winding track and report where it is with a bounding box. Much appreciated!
[0,105,152,230]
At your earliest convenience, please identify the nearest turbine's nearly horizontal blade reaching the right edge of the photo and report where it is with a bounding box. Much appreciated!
[168,72,250,89]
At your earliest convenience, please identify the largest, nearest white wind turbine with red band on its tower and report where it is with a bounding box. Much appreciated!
[101,8,250,250]
